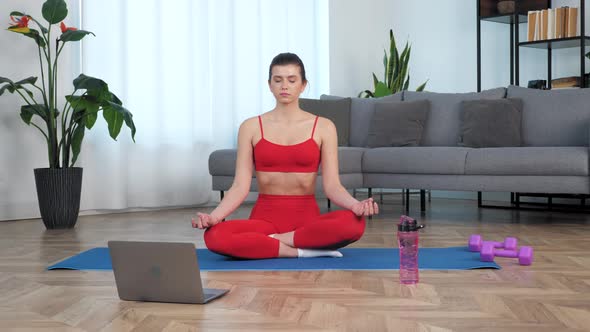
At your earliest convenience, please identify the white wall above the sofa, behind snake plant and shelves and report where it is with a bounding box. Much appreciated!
[330,0,590,96]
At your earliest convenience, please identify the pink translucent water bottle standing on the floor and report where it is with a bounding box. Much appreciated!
[397,216,424,284]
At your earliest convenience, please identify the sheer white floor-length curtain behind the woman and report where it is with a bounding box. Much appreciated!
[80,0,329,210]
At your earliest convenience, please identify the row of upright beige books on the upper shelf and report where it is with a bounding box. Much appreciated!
[527,6,579,41]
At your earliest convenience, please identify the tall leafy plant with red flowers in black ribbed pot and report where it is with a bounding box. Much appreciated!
[0,0,136,229]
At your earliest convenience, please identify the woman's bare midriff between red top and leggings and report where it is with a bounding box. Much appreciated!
[256,172,317,195]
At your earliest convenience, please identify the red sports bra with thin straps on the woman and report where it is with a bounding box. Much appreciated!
[254,116,321,173]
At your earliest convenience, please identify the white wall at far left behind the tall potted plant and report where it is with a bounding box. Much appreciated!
[0,0,77,220]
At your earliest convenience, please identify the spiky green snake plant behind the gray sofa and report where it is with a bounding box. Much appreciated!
[359,29,428,98]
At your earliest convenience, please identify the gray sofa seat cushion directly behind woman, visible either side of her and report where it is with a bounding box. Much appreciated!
[209,147,367,176]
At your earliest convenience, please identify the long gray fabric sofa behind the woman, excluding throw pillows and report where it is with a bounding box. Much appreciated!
[209,86,590,210]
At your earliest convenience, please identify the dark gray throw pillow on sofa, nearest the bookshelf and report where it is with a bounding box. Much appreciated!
[459,98,522,148]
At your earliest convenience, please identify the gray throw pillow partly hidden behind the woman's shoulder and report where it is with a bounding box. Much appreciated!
[299,98,351,146]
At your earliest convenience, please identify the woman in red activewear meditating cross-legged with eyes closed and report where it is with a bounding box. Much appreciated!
[192,53,378,259]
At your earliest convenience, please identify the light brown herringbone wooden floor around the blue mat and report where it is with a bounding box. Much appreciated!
[0,197,590,332]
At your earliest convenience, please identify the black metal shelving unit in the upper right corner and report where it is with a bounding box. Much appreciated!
[476,0,590,91]
